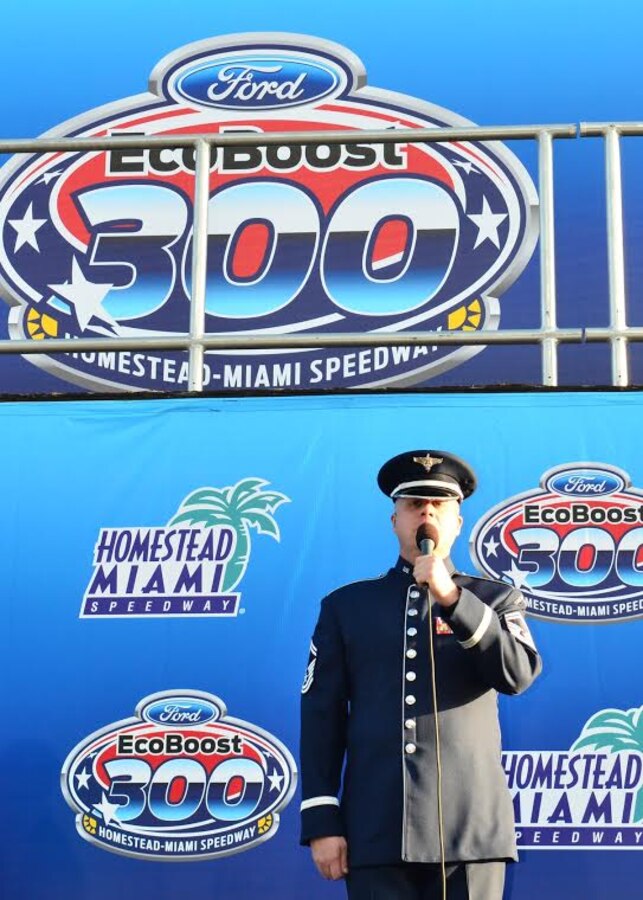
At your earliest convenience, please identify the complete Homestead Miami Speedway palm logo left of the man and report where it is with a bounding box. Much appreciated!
[80,478,289,618]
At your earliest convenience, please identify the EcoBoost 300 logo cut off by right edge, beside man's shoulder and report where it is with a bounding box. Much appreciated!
[470,462,643,622]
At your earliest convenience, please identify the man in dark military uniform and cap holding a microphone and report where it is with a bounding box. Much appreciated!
[301,450,541,900]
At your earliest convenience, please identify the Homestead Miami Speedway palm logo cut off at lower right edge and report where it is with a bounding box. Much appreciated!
[502,706,643,850]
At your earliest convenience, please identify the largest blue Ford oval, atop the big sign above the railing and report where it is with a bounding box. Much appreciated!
[174,56,341,110]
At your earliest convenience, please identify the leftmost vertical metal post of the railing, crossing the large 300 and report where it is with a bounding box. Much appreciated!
[188,141,210,391]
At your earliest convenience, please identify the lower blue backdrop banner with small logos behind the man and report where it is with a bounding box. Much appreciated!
[0,393,643,900]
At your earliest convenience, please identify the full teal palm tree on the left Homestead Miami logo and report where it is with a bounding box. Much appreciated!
[168,478,290,592]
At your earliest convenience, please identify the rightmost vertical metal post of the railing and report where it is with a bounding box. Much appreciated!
[605,125,629,387]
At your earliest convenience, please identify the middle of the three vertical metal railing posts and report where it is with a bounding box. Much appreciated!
[538,131,558,387]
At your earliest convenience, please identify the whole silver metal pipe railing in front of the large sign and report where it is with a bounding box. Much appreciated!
[0,122,643,392]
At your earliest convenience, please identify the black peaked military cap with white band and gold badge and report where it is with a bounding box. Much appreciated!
[377,450,477,500]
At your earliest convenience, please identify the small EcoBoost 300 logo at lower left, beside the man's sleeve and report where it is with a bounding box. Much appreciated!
[62,691,296,861]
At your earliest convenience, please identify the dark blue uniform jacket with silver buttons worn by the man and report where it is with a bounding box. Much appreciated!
[301,559,541,866]
